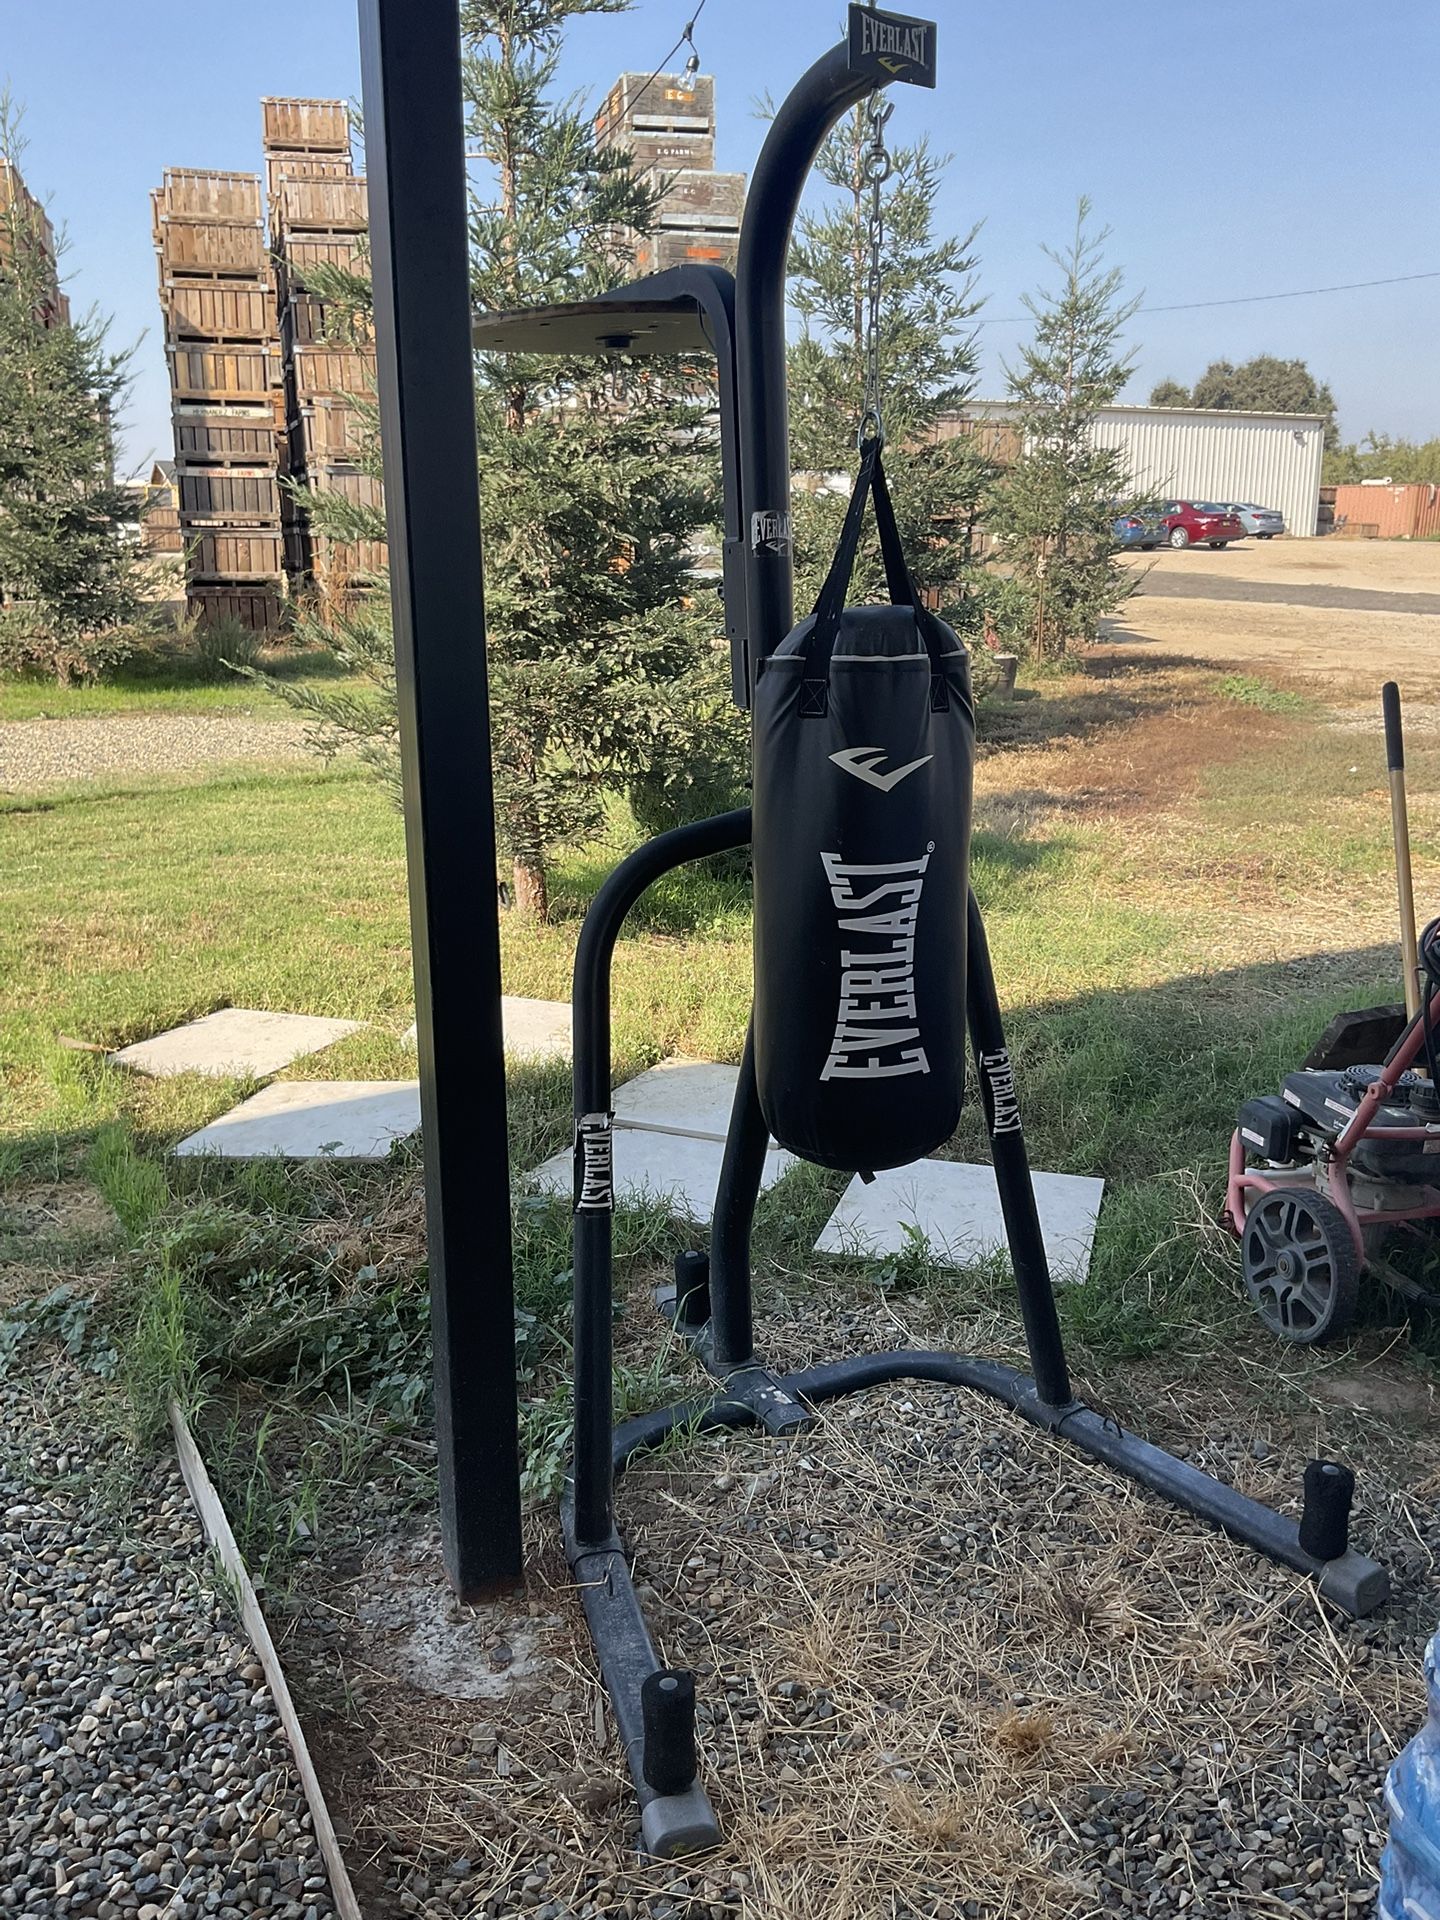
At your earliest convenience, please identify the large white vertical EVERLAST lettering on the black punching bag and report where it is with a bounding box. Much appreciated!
[820,841,935,1081]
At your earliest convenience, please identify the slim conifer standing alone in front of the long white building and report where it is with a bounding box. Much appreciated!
[991,200,1137,659]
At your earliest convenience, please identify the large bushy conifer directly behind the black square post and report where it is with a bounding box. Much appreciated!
[278,0,739,916]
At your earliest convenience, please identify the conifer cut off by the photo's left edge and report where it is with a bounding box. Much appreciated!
[0,96,142,684]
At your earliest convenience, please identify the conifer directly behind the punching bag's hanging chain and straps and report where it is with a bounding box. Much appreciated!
[789,106,995,645]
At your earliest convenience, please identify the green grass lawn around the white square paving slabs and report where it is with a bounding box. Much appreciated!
[0,652,1440,1520]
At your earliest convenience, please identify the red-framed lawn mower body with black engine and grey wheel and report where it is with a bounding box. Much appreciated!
[1227,1060,1440,1346]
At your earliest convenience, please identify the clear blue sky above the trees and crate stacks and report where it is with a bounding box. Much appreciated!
[0,0,1440,480]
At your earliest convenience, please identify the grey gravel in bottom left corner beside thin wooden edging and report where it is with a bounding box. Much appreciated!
[0,1380,334,1920]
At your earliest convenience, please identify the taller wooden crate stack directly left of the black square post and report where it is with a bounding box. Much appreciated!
[261,100,386,595]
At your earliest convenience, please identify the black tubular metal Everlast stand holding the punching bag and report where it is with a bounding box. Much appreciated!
[474,6,1390,1857]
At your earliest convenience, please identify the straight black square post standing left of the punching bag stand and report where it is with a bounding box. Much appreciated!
[359,0,522,1599]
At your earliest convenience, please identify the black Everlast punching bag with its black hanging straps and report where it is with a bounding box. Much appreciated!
[755,444,975,1173]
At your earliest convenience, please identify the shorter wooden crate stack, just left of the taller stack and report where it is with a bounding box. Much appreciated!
[152,167,282,632]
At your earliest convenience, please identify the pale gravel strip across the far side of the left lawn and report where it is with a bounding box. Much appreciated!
[0,714,309,793]
